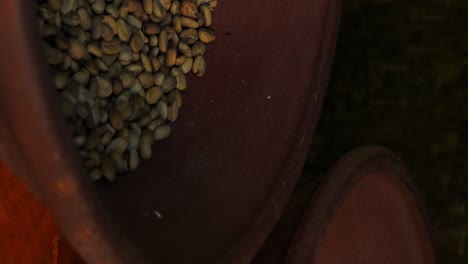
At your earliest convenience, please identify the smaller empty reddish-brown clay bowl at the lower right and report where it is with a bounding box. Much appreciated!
[254,147,437,264]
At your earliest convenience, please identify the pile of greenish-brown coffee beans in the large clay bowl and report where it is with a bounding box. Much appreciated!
[38,0,217,182]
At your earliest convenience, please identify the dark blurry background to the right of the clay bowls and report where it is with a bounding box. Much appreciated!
[306,0,468,263]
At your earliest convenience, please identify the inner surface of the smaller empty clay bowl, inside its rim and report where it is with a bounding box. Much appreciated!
[315,172,434,264]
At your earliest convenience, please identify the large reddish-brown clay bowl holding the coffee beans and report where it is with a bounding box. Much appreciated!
[0,0,339,264]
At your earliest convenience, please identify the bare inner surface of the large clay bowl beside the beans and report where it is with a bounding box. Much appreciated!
[93,0,333,263]
